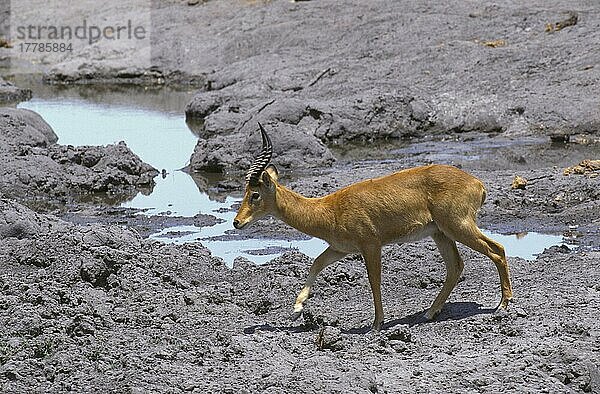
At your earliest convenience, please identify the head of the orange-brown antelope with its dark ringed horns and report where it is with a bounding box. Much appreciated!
[233,123,278,229]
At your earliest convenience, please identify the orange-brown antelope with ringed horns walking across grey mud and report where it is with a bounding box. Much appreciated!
[233,123,512,331]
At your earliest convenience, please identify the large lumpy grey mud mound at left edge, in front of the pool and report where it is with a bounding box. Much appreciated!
[0,108,158,206]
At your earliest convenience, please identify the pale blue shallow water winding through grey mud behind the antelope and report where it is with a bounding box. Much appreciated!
[19,89,563,266]
